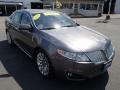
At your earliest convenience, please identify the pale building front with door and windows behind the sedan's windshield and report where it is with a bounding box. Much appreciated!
[43,0,104,16]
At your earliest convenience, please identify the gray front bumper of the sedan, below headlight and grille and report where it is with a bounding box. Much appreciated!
[50,48,115,80]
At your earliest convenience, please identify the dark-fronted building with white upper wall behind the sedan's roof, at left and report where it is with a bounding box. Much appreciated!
[0,0,43,16]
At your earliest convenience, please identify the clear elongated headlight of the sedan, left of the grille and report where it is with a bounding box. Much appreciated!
[57,49,90,62]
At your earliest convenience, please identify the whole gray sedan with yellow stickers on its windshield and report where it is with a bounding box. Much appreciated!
[5,9,115,80]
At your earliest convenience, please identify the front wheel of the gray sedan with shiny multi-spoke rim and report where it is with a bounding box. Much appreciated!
[35,50,53,78]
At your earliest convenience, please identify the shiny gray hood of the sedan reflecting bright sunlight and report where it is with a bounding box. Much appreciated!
[42,26,110,52]
